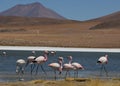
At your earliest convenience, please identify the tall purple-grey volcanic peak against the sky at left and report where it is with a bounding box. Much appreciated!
[0,2,65,19]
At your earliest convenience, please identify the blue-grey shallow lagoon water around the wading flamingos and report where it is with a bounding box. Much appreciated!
[0,46,120,82]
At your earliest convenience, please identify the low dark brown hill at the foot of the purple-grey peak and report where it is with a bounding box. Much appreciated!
[0,16,80,27]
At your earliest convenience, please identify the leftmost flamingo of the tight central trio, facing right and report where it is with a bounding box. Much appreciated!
[48,57,63,80]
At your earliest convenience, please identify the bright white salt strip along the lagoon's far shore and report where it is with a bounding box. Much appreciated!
[0,46,120,53]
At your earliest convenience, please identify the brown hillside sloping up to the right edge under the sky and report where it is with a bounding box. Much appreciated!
[89,11,120,29]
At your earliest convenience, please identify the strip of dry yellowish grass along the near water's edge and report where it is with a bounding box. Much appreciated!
[0,78,120,86]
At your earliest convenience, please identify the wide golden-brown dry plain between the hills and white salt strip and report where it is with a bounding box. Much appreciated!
[0,17,120,48]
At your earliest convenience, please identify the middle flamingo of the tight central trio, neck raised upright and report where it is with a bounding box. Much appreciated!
[63,56,74,78]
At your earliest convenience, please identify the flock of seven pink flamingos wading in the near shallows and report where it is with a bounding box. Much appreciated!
[16,51,108,80]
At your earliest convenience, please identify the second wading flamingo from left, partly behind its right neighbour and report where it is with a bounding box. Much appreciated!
[25,51,36,75]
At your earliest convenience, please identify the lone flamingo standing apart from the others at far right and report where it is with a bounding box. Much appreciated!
[97,55,108,76]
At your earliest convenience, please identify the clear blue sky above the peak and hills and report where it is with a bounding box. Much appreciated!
[0,0,120,21]
